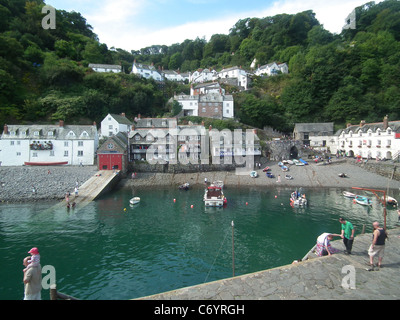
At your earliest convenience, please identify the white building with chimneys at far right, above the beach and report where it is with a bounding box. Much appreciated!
[332,116,400,160]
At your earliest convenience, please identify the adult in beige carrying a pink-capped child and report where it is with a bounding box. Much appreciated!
[23,256,42,300]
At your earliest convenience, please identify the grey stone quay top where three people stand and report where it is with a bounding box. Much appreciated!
[139,228,400,300]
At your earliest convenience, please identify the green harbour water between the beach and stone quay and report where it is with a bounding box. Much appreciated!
[0,187,399,300]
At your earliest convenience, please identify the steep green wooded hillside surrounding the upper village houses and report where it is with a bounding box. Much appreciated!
[0,0,400,131]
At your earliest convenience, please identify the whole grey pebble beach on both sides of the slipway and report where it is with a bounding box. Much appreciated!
[0,161,400,203]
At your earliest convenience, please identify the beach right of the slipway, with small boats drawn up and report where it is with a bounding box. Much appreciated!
[123,161,400,190]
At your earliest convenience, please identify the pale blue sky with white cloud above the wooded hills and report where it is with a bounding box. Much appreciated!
[45,0,380,51]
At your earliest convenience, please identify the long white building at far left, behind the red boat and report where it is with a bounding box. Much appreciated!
[0,120,99,166]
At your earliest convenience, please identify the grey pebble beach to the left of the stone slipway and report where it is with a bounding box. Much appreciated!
[0,166,98,202]
